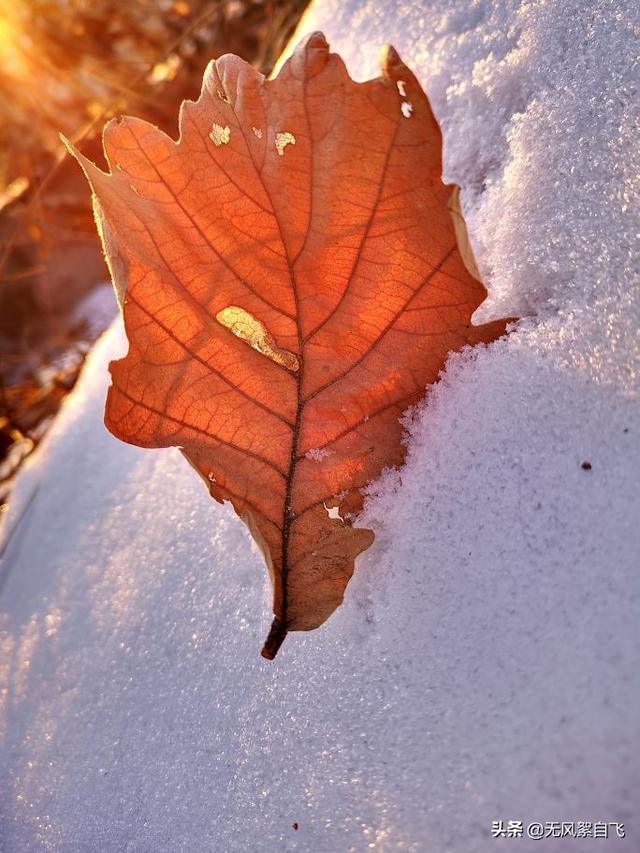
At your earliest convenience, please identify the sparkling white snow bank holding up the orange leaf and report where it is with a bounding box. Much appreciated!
[0,0,640,853]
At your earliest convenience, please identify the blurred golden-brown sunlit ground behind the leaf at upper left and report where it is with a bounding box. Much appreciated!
[0,0,308,513]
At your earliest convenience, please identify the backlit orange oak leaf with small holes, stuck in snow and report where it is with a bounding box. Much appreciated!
[70,33,505,658]
